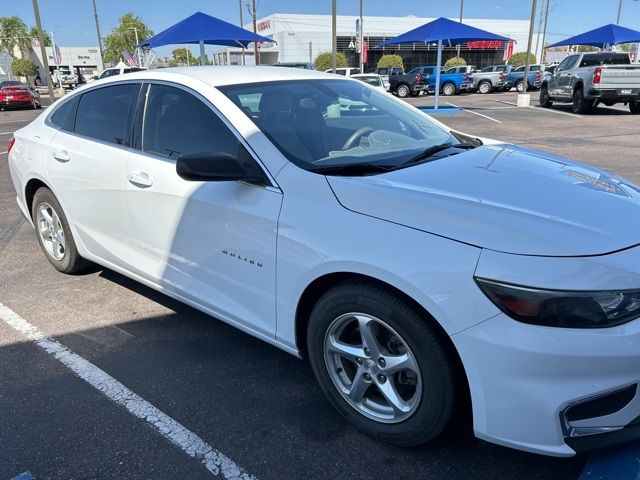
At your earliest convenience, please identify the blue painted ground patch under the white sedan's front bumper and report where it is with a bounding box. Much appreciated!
[579,443,640,480]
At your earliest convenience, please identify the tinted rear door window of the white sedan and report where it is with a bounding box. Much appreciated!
[75,83,140,145]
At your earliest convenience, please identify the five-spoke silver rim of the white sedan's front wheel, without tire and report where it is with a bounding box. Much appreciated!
[324,312,423,423]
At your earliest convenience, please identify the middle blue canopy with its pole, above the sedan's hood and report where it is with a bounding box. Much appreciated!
[376,17,510,109]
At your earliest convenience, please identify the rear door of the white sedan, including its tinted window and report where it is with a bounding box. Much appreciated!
[46,83,141,266]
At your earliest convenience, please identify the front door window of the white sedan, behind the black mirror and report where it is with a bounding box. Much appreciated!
[142,84,239,158]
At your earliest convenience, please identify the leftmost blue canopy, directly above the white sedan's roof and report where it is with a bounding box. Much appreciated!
[139,12,273,65]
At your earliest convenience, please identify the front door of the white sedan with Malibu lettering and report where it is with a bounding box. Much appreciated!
[125,83,282,337]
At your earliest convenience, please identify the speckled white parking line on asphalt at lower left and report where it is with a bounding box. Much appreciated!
[0,303,255,480]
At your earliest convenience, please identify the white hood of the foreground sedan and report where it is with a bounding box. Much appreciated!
[327,144,640,256]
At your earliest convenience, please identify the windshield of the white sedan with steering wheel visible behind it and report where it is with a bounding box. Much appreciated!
[219,79,457,170]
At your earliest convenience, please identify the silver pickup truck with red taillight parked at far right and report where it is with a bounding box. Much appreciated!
[540,52,640,114]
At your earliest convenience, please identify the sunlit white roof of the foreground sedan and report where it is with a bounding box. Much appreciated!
[101,66,347,87]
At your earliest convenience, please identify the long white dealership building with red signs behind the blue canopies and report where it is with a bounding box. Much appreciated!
[213,13,537,69]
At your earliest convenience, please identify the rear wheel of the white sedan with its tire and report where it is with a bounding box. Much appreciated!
[31,187,89,274]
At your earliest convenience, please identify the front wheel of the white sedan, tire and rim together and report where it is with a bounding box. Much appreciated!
[307,282,461,446]
